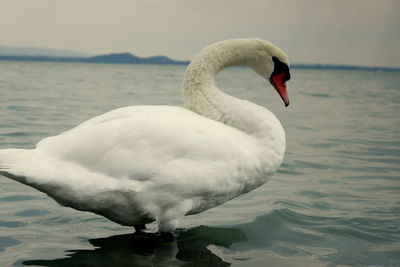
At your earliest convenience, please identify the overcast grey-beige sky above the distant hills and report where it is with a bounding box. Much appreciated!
[0,0,400,67]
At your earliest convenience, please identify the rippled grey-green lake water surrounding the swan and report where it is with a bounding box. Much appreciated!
[0,62,400,266]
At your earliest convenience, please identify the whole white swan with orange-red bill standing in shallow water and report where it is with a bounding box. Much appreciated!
[0,39,290,241]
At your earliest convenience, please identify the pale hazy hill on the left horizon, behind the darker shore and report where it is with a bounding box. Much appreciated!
[0,45,92,57]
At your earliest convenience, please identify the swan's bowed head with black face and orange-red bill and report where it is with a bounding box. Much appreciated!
[247,39,290,107]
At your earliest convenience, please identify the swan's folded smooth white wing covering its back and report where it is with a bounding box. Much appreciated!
[37,106,254,181]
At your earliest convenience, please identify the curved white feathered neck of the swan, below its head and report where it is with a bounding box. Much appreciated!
[183,40,281,141]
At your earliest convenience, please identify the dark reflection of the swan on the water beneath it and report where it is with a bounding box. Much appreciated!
[23,226,247,267]
